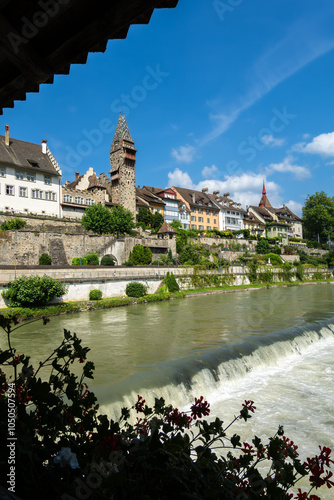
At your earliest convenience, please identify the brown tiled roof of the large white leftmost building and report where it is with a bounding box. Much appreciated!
[0,135,61,176]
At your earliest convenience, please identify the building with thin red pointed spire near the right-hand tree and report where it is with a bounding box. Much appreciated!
[248,181,303,240]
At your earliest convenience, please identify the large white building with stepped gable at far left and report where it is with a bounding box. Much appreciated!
[0,125,62,217]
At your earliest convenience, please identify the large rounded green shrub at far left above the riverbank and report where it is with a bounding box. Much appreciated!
[2,275,67,307]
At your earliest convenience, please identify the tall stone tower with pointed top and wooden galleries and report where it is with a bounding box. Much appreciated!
[110,116,136,217]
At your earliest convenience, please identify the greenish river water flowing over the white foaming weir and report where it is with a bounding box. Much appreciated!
[1,285,334,500]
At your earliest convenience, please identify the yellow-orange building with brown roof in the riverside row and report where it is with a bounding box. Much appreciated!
[172,186,219,231]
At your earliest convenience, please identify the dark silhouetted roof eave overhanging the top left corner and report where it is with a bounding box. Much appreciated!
[0,0,178,114]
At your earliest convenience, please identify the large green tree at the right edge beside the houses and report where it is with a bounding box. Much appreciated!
[303,191,334,243]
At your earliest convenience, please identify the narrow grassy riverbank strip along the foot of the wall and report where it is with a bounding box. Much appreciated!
[0,279,334,320]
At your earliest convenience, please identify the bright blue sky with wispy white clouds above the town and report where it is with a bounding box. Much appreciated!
[0,0,334,214]
